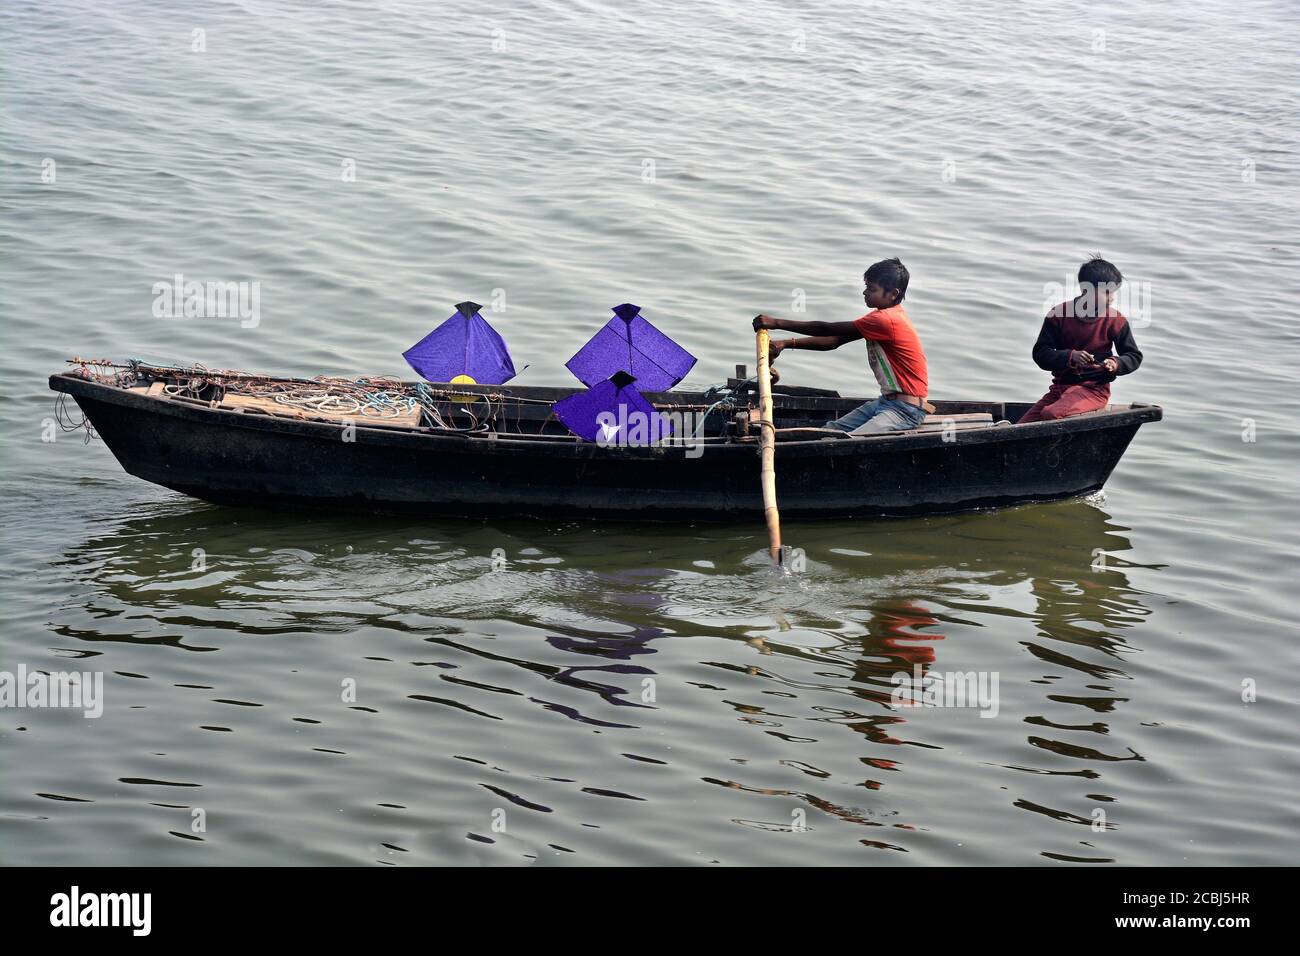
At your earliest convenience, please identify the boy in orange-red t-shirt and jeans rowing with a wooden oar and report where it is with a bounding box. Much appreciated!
[754,259,930,434]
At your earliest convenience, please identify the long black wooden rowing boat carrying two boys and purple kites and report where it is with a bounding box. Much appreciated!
[49,360,1162,522]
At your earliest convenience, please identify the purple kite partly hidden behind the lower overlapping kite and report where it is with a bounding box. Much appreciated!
[564,303,696,392]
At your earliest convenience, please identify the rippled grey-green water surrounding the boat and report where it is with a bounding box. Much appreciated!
[0,1,1300,865]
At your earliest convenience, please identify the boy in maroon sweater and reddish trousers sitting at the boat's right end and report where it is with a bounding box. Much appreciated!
[1017,256,1141,425]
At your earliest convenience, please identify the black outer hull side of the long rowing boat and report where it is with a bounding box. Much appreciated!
[49,375,1161,522]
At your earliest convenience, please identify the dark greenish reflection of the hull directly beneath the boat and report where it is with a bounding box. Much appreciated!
[60,498,1154,608]
